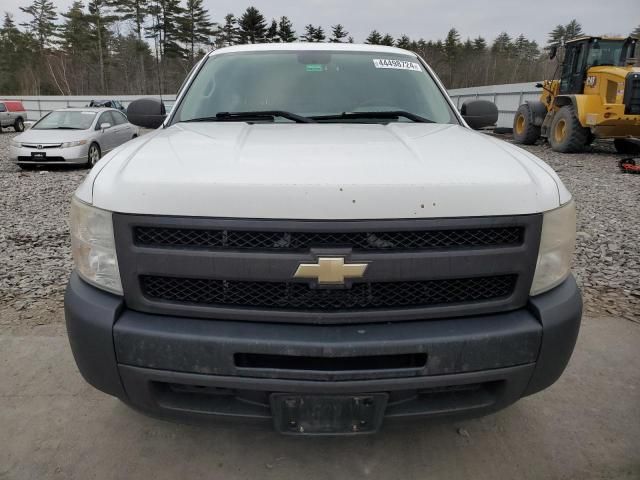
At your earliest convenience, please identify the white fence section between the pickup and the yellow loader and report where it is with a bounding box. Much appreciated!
[449,82,541,129]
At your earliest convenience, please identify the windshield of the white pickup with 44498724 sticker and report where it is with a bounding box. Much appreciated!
[173,51,457,123]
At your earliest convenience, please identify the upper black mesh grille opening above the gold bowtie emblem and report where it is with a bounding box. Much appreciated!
[134,227,524,251]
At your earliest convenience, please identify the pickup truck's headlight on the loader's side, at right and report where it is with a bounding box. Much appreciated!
[530,200,576,296]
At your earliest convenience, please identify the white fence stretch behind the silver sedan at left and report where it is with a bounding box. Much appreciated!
[1,95,176,121]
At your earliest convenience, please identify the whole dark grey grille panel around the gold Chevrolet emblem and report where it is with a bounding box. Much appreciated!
[113,213,542,325]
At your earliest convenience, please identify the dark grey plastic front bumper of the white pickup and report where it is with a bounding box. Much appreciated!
[65,273,582,430]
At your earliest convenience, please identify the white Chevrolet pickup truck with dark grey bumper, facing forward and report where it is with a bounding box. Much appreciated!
[66,44,582,435]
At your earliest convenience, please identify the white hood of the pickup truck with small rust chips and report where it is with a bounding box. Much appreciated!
[77,122,570,220]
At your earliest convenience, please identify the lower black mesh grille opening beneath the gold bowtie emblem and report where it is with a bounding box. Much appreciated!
[140,275,517,311]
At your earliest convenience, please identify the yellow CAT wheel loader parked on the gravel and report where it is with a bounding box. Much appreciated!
[513,37,640,154]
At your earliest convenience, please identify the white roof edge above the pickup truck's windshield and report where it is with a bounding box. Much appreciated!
[209,42,416,57]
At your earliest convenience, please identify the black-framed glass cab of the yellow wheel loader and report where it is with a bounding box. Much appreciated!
[560,37,637,95]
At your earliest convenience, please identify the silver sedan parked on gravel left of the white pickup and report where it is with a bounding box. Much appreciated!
[10,108,138,168]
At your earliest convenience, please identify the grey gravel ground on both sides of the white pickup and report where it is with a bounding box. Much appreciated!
[0,132,640,326]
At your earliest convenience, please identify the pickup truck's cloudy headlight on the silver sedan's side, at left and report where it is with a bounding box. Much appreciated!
[69,197,122,295]
